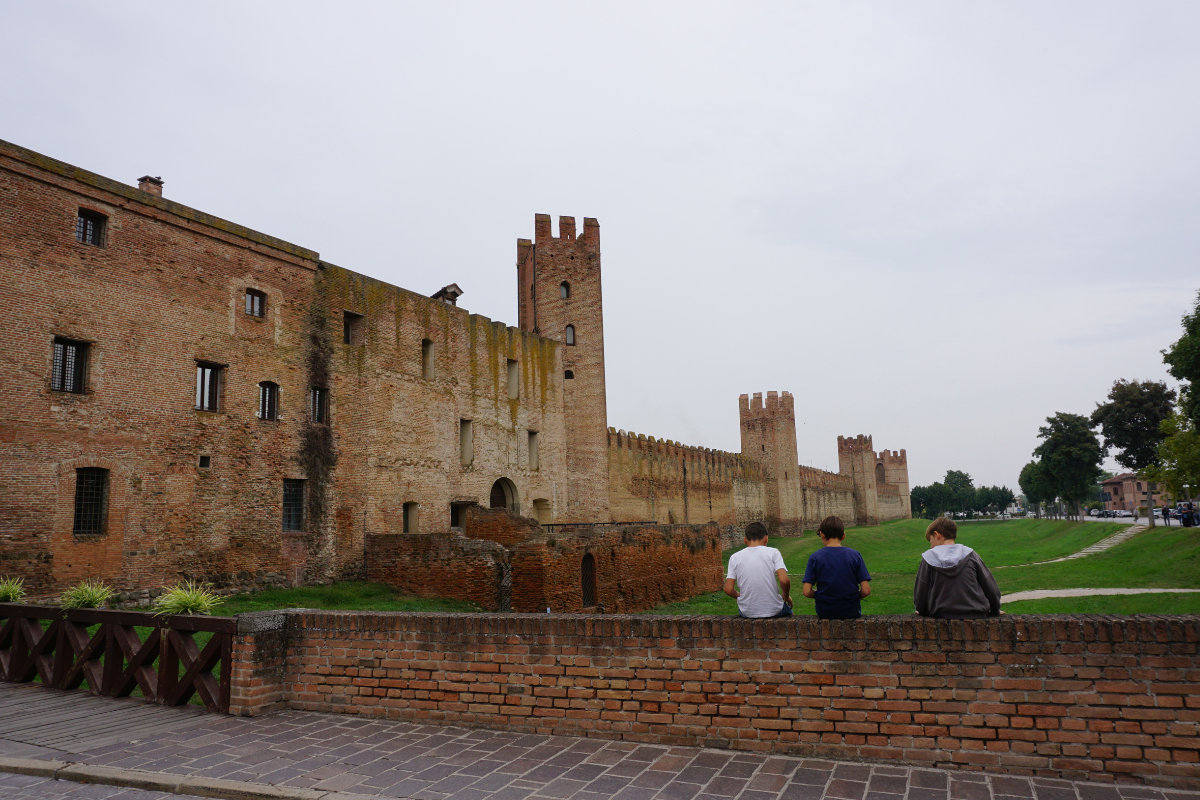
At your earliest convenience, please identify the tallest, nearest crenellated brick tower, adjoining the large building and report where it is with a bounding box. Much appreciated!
[517,213,610,522]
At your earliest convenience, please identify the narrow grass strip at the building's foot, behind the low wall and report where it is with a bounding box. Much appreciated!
[214,582,479,616]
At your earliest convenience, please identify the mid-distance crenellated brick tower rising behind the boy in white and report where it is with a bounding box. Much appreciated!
[738,392,802,535]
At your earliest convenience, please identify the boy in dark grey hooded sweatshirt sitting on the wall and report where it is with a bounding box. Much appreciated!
[912,517,1000,619]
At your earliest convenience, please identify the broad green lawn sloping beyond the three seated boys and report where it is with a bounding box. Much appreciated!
[646,519,1185,614]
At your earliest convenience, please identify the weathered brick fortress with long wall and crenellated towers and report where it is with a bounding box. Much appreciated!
[0,143,907,597]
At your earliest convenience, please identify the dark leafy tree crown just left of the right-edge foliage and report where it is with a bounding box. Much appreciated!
[1092,380,1175,473]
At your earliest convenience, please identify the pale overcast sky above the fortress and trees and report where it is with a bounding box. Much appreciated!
[0,0,1200,488]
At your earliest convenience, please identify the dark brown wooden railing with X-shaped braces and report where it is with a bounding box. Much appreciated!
[0,603,238,714]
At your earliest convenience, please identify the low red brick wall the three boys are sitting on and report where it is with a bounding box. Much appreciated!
[232,609,1200,788]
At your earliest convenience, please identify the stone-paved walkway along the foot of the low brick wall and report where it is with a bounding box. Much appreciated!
[0,684,1200,800]
